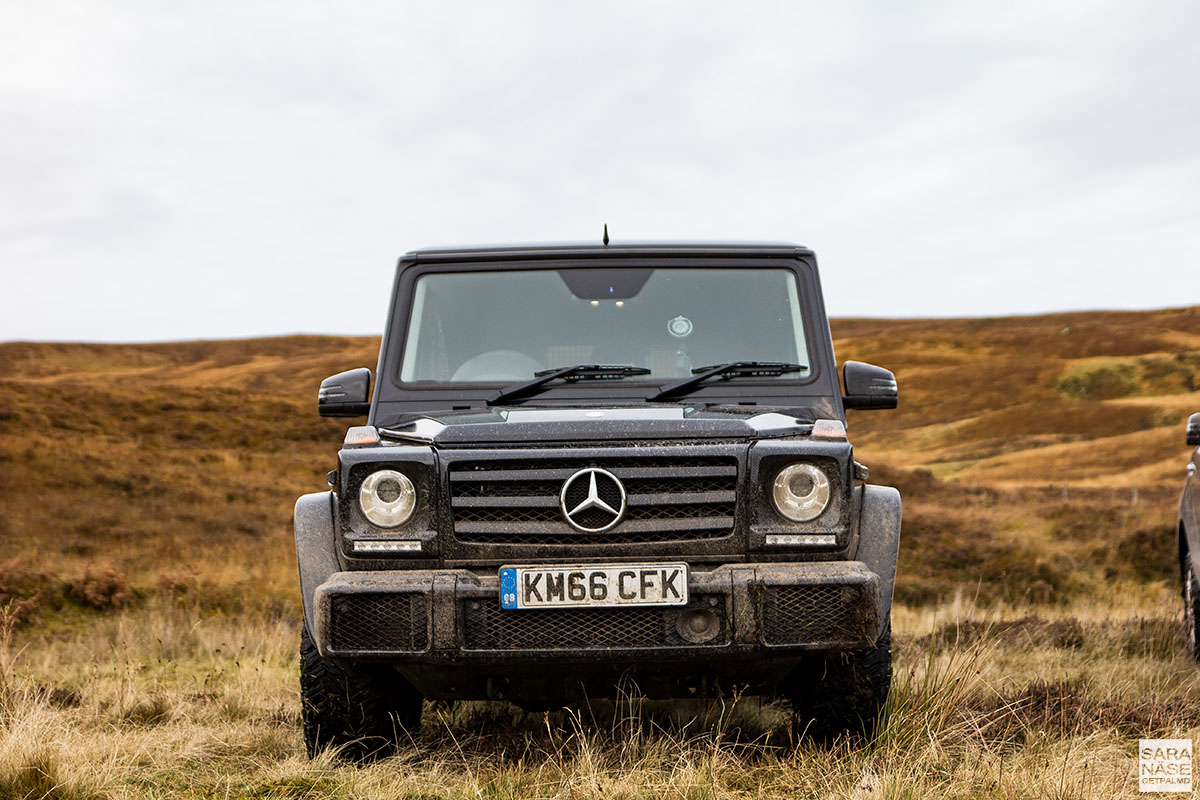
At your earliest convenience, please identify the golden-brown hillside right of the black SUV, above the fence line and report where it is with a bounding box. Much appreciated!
[833,307,1200,486]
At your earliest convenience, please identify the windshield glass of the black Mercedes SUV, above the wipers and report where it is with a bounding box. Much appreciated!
[401,266,809,383]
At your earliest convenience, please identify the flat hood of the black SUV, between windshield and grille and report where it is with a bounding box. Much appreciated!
[379,405,812,445]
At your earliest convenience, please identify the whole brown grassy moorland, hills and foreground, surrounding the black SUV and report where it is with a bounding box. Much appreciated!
[0,308,1200,799]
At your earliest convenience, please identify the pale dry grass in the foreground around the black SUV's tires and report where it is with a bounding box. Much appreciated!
[0,594,1200,799]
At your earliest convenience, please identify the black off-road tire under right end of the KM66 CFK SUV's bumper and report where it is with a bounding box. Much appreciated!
[782,620,892,741]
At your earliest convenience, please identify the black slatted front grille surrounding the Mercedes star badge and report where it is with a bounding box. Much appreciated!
[450,456,738,545]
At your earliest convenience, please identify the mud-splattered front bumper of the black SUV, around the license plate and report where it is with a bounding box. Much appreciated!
[312,561,881,667]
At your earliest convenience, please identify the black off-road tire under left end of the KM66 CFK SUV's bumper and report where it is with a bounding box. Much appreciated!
[300,627,422,762]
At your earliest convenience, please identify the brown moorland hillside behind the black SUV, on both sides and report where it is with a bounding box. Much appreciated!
[0,308,1200,620]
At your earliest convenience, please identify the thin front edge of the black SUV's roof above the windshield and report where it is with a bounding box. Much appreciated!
[400,241,812,263]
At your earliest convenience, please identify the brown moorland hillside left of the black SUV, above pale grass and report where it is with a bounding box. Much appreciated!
[0,336,379,615]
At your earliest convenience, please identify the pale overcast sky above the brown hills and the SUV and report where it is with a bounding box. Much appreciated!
[0,0,1200,341]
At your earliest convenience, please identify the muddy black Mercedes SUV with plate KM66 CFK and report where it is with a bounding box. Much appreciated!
[295,245,900,757]
